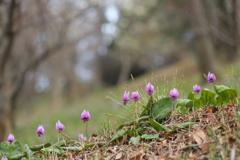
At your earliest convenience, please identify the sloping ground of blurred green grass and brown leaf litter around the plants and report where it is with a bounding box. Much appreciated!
[6,59,240,160]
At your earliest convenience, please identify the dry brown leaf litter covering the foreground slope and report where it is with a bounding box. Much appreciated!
[53,104,240,160]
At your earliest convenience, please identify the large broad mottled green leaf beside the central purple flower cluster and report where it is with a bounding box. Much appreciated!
[152,98,173,121]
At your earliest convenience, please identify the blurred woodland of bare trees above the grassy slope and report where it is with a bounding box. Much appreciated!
[0,0,240,141]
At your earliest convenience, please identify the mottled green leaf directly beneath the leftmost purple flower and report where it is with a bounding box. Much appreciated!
[0,141,23,157]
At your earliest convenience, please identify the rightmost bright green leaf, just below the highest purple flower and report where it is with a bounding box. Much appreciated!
[214,85,237,103]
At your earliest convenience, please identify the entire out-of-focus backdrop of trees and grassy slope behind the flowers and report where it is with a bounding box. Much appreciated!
[0,0,240,144]
